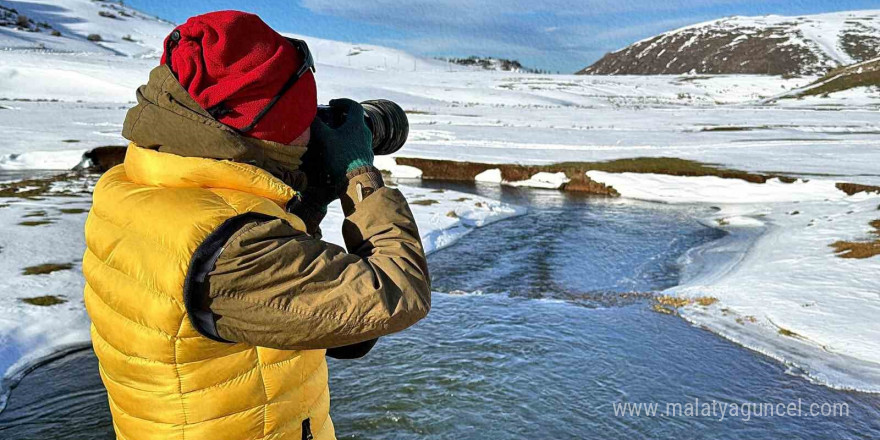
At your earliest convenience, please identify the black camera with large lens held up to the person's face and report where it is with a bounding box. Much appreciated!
[317,99,409,155]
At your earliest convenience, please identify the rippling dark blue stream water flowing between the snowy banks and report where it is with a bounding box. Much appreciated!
[0,185,880,439]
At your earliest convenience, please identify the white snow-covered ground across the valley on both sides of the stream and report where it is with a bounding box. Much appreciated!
[0,0,880,398]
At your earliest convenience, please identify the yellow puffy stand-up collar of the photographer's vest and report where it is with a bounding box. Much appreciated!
[124,143,297,206]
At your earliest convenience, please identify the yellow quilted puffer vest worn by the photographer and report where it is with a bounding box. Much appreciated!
[83,144,335,440]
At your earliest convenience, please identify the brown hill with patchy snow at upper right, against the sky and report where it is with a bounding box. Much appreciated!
[578,10,880,75]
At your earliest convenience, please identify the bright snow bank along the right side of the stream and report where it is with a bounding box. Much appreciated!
[588,172,880,392]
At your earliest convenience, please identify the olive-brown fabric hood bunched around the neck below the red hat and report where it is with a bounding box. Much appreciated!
[122,65,306,183]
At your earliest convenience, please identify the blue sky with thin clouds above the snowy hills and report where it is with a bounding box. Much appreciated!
[125,0,880,73]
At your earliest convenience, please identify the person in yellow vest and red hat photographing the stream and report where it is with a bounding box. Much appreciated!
[83,11,431,440]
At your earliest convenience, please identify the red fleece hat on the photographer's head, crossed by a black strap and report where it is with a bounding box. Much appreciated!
[162,11,318,144]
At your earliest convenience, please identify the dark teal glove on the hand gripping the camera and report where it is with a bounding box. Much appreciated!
[309,99,373,187]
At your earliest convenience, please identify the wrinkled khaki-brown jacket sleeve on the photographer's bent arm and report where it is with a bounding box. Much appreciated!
[204,169,431,349]
